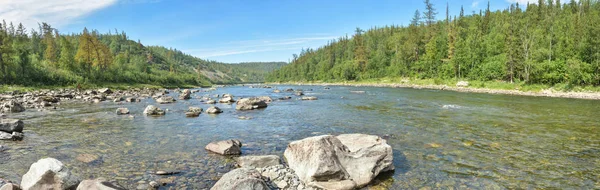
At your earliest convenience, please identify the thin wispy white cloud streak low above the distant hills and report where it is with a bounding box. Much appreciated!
[188,36,337,58]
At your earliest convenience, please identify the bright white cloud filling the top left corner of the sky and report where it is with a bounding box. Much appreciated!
[0,0,117,28]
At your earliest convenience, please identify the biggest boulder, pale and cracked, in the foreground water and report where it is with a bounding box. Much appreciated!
[284,134,394,189]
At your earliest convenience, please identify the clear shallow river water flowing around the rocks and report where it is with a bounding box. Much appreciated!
[0,86,600,189]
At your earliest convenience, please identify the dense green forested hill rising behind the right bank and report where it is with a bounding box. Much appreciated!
[268,0,600,86]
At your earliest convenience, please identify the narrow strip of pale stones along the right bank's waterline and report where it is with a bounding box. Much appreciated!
[274,81,600,100]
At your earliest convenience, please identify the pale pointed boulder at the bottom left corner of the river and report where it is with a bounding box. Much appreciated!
[21,158,80,190]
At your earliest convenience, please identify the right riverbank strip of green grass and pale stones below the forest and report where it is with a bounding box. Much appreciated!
[271,79,600,100]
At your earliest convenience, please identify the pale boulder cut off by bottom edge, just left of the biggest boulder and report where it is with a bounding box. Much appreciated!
[211,168,270,190]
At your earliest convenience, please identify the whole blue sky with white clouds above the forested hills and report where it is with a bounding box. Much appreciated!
[0,0,531,63]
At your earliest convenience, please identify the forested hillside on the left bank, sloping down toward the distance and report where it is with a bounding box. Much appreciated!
[0,22,284,86]
